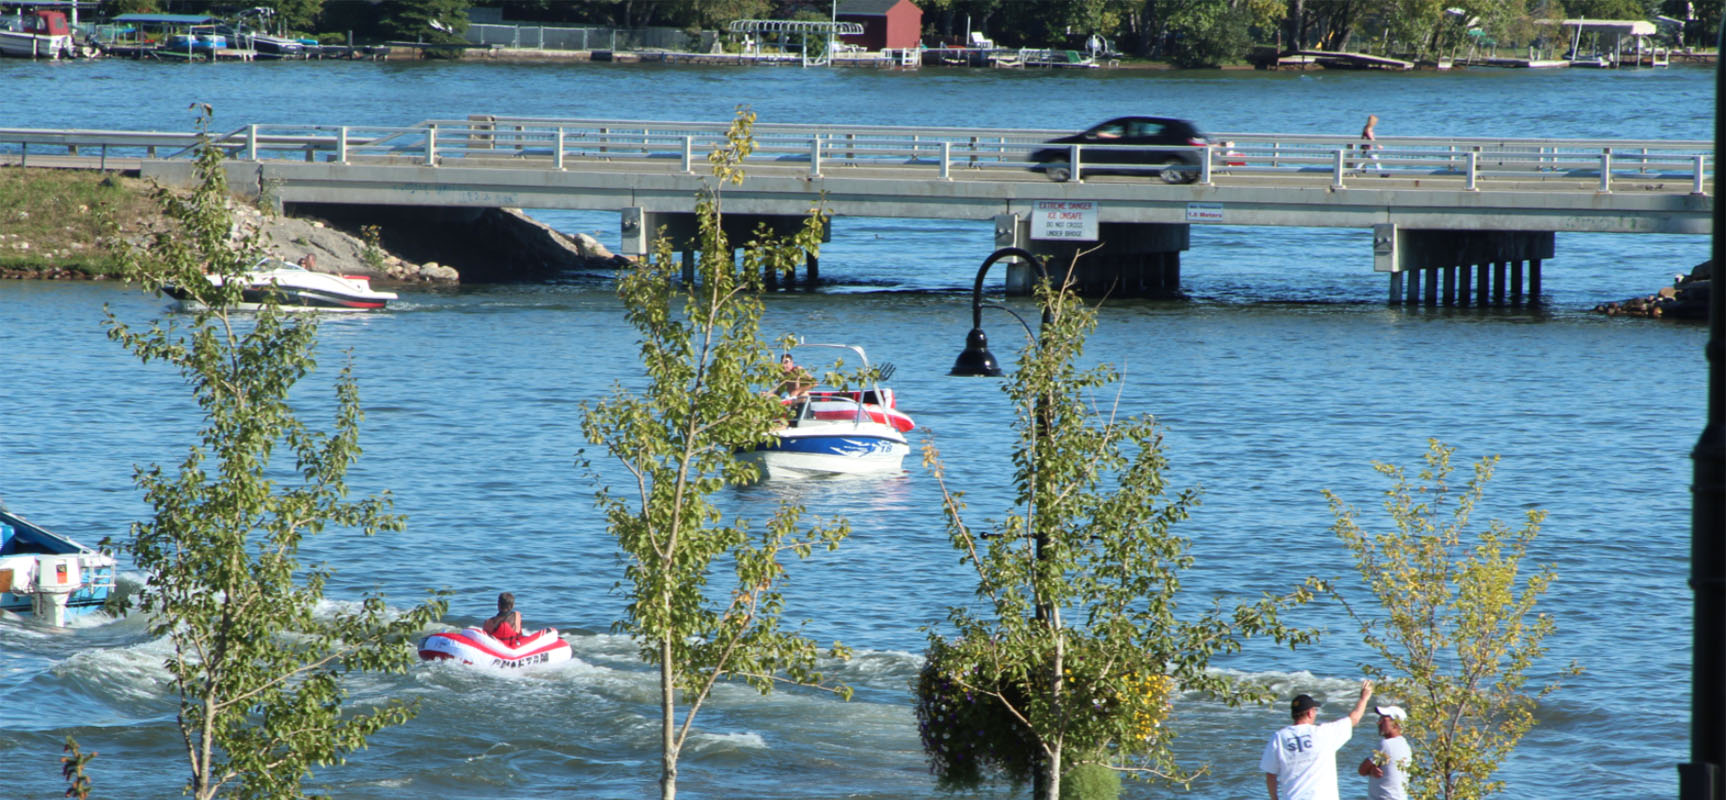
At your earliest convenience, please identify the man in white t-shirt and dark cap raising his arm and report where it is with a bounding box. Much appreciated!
[1258,681,1372,800]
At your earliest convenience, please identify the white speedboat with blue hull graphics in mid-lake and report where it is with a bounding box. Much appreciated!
[739,344,917,480]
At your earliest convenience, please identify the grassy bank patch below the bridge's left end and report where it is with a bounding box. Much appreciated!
[0,168,162,275]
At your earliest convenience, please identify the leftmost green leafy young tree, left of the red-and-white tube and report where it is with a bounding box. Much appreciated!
[107,105,444,800]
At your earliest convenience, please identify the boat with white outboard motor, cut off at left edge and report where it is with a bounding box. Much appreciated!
[0,508,114,627]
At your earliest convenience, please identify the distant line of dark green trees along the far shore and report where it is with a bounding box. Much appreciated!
[91,0,1723,66]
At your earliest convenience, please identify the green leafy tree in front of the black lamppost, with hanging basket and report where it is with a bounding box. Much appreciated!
[917,271,1313,798]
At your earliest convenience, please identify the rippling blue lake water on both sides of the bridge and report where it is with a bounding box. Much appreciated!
[0,60,1714,800]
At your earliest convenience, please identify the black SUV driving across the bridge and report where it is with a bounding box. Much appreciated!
[1030,117,1206,183]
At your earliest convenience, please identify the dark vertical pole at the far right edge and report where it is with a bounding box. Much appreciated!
[1678,19,1726,800]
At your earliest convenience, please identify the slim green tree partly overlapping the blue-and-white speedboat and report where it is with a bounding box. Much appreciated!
[582,111,849,800]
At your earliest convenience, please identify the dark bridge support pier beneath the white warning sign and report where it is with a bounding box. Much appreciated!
[994,214,1191,297]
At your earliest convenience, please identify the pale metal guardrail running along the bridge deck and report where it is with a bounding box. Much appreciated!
[0,116,1716,195]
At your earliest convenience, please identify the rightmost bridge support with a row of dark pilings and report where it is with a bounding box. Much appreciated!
[1372,223,1555,306]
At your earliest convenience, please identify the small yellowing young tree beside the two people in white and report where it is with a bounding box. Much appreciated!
[1324,439,1581,800]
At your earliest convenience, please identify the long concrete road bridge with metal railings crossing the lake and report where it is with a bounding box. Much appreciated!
[0,116,1716,304]
